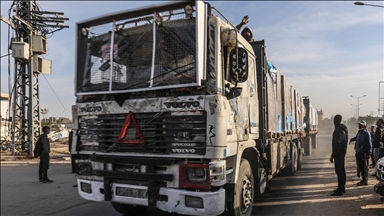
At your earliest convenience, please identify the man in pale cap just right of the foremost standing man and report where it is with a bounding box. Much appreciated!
[355,120,372,186]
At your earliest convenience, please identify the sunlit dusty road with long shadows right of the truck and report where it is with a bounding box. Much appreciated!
[252,135,384,216]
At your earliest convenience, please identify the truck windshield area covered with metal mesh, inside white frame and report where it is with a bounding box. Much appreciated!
[77,5,197,93]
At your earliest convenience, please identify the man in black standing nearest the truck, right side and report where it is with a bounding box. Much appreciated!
[329,115,348,196]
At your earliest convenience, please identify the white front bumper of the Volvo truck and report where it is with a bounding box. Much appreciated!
[77,179,225,215]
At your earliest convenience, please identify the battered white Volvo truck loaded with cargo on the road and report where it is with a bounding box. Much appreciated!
[72,1,317,215]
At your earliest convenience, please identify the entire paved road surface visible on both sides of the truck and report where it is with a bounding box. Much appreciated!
[1,132,384,216]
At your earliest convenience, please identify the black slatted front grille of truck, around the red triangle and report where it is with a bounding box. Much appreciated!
[79,111,206,155]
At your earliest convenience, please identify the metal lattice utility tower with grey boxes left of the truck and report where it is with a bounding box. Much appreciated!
[1,0,69,155]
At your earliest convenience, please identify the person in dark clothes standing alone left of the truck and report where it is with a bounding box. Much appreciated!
[39,126,53,183]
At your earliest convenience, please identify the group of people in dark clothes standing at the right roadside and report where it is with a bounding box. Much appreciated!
[330,115,384,196]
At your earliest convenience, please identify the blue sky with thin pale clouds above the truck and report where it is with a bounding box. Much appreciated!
[1,0,384,119]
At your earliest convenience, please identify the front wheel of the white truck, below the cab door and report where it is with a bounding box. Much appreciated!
[228,159,255,216]
